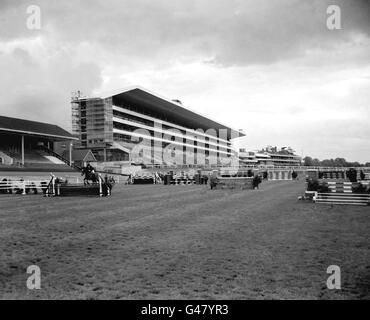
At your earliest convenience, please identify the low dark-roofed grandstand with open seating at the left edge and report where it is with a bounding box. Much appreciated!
[0,116,77,172]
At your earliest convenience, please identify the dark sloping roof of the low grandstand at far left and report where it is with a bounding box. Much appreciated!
[0,116,77,141]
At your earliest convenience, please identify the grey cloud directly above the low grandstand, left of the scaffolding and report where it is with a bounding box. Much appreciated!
[0,38,102,128]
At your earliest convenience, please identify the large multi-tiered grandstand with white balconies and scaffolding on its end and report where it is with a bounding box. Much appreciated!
[72,86,245,167]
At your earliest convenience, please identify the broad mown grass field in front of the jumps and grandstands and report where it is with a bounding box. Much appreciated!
[0,181,370,299]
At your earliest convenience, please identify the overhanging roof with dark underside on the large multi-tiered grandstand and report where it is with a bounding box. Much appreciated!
[76,86,245,137]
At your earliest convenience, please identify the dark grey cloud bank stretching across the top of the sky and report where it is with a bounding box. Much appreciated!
[0,0,370,66]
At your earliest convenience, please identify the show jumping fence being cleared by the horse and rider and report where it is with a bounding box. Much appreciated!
[45,174,112,197]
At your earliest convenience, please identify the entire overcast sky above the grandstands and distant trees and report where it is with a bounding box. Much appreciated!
[0,0,370,163]
